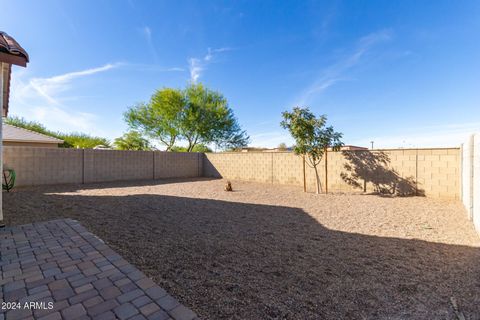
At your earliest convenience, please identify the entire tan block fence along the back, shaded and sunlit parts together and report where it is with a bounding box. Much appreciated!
[3,146,462,200]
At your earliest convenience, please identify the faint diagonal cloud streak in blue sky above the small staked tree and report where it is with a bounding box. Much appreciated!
[294,30,392,106]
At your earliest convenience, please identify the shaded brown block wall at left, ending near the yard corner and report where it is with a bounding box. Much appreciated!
[3,146,203,186]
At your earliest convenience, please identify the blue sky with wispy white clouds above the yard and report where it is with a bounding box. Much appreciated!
[0,0,480,147]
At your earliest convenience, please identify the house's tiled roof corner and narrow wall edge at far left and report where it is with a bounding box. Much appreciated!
[0,31,29,117]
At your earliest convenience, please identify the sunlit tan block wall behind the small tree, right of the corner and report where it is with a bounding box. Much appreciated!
[203,148,461,199]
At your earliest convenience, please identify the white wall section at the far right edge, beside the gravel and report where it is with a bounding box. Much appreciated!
[461,134,480,233]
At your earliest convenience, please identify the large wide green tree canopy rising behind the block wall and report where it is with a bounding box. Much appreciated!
[124,84,249,152]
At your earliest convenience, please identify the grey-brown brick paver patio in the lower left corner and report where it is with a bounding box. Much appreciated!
[0,219,197,320]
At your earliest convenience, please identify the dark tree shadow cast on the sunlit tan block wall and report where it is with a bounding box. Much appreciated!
[340,150,425,197]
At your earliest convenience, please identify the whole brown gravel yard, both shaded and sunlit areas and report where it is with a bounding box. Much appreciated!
[3,179,480,319]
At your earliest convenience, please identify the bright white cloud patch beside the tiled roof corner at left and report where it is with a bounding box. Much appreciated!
[10,64,119,132]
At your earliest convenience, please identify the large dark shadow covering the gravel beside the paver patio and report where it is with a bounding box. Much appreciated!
[4,191,480,319]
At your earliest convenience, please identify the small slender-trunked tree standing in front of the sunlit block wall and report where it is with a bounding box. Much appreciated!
[280,107,343,193]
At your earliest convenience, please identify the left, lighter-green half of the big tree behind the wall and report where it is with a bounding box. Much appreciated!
[124,88,185,151]
